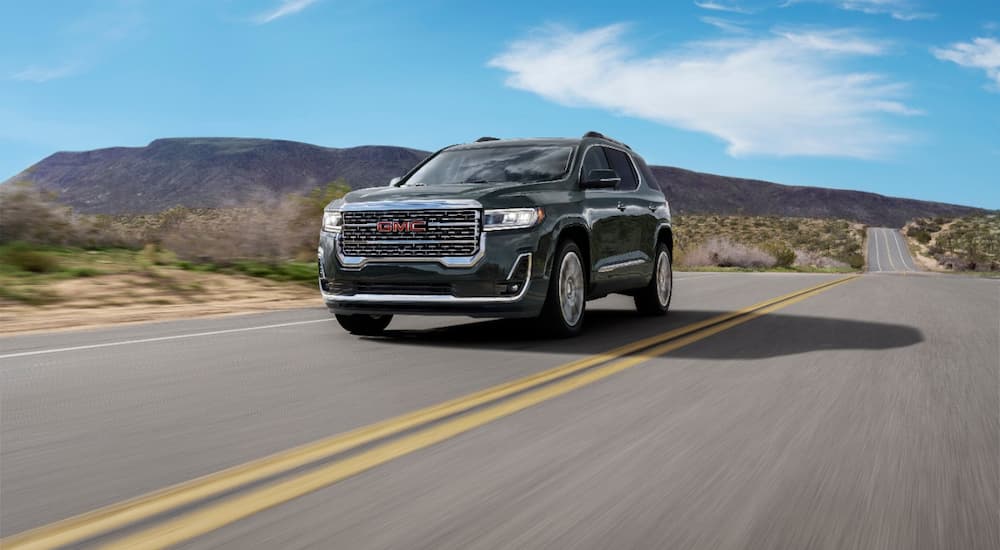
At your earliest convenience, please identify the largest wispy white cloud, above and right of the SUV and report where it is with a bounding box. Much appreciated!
[489,24,916,158]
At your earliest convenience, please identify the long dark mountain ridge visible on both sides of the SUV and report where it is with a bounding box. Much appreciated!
[1,138,982,227]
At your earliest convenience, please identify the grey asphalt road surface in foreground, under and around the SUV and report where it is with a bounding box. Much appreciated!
[0,274,1000,550]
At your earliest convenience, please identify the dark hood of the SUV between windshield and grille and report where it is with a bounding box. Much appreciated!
[327,183,543,209]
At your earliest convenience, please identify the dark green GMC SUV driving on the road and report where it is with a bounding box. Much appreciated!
[319,132,673,336]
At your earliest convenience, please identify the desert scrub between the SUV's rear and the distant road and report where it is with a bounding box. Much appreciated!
[674,215,865,271]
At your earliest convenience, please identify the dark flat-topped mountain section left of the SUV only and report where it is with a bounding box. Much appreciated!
[9,138,428,214]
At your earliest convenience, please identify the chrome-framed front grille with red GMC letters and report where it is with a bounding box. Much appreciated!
[340,209,481,258]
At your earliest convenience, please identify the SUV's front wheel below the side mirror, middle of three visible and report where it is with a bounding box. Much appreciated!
[538,241,587,338]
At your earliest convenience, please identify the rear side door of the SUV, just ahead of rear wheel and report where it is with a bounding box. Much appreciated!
[604,147,655,288]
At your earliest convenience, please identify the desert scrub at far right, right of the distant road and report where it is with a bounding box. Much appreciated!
[905,213,1000,271]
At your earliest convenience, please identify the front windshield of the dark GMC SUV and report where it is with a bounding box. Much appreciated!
[406,145,573,185]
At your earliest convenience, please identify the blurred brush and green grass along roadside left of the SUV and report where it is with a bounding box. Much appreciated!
[0,181,348,305]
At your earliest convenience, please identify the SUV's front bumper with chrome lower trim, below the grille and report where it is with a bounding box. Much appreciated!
[319,231,548,317]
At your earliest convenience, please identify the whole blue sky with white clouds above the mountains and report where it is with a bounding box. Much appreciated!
[0,0,1000,208]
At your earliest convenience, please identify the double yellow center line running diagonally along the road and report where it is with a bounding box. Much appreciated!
[0,276,856,550]
